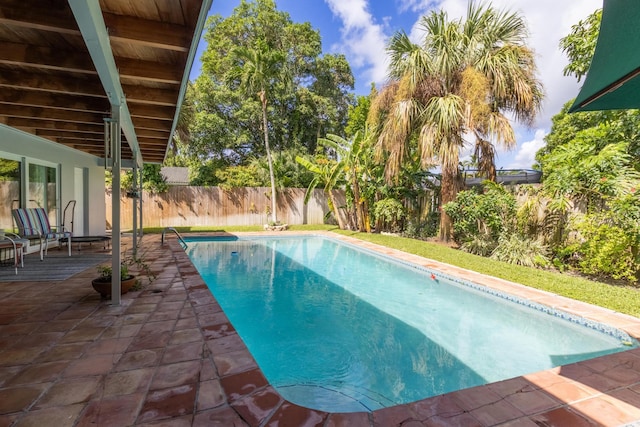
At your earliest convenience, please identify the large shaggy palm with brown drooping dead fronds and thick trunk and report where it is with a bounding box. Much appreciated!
[372,2,543,240]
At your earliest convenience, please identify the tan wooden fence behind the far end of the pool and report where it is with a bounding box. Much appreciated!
[106,186,345,228]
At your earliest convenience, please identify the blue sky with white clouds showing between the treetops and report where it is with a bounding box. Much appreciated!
[191,0,602,169]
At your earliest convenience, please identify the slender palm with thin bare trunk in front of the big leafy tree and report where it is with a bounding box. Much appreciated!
[231,43,287,223]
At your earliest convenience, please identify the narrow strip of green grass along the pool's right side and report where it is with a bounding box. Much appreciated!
[333,230,640,317]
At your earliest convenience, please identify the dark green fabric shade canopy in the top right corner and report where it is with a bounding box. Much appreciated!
[569,0,640,112]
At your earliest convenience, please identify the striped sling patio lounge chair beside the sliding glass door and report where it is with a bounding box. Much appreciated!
[11,208,71,260]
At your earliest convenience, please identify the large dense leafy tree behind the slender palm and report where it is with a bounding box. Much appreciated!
[190,0,354,165]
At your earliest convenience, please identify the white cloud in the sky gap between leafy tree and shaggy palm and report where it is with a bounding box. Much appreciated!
[325,0,387,84]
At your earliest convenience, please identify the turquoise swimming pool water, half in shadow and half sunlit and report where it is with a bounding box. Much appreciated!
[187,237,637,412]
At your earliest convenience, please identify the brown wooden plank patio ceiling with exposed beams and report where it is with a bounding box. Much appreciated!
[0,0,203,163]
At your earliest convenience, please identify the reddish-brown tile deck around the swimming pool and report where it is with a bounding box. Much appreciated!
[0,233,640,427]
